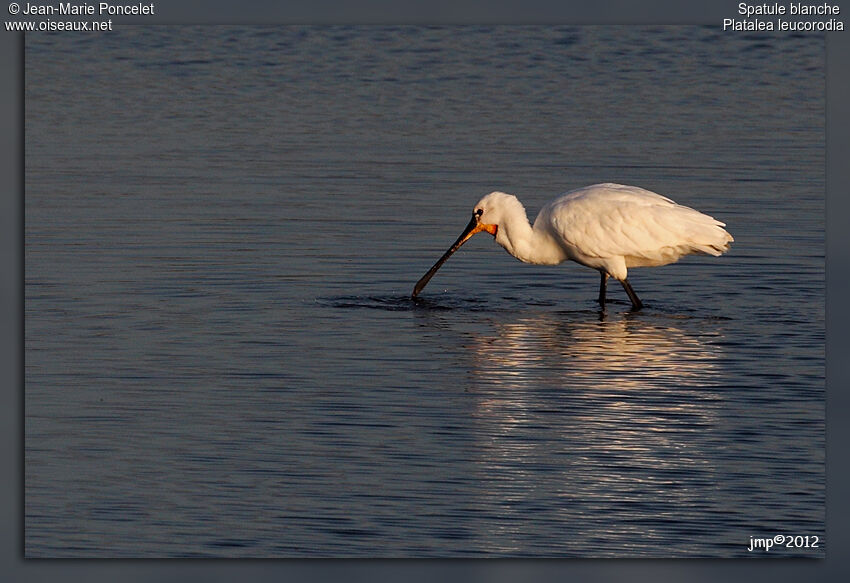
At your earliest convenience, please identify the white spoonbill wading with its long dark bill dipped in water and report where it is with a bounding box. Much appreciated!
[412,183,733,310]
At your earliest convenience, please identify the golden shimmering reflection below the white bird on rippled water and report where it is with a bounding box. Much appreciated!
[454,313,722,555]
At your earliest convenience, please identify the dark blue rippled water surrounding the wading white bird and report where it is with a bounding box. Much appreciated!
[25,26,826,557]
